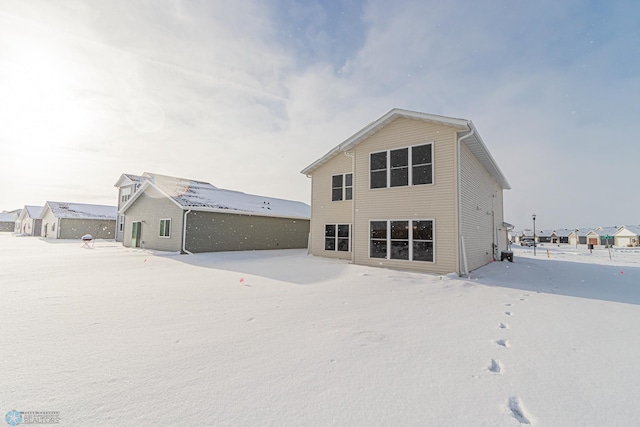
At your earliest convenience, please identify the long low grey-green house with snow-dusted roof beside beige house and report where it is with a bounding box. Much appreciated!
[119,173,310,253]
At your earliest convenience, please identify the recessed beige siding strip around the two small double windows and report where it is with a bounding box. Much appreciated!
[310,153,355,260]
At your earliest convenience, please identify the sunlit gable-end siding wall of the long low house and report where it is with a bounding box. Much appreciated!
[123,187,183,252]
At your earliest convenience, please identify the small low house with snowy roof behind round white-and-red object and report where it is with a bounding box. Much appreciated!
[40,202,118,239]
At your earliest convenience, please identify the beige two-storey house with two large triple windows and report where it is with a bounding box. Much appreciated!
[302,109,511,274]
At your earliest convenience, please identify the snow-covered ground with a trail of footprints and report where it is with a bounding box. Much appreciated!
[0,233,640,426]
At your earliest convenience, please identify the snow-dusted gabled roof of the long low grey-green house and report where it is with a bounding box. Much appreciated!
[120,172,311,219]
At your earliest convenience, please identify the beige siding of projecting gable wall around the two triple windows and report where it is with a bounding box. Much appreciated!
[353,118,458,274]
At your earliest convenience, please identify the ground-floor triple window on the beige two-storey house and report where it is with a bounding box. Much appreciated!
[369,220,434,262]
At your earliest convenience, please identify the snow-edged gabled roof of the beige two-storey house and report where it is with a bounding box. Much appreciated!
[301,108,511,190]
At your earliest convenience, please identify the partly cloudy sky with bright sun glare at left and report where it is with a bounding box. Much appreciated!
[0,0,640,229]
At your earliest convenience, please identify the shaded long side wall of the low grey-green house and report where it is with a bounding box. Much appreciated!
[185,211,309,253]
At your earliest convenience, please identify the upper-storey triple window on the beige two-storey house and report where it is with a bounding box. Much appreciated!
[369,144,433,188]
